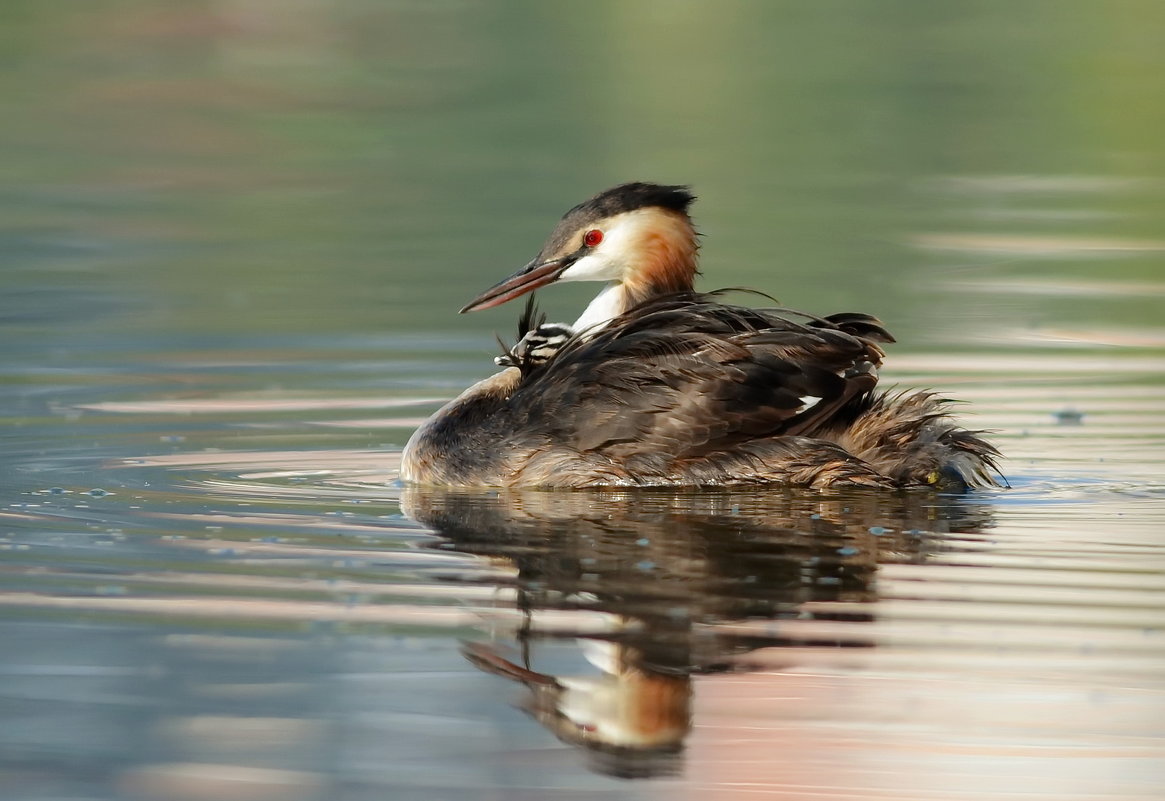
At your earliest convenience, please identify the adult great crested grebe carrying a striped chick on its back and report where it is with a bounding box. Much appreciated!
[401,183,998,490]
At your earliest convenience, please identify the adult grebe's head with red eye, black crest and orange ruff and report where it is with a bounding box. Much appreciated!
[461,183,698,316]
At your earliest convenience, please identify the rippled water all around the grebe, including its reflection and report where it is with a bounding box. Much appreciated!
[0,0,1165,801]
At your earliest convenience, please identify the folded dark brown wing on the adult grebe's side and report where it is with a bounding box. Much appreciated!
[511,295,890,474]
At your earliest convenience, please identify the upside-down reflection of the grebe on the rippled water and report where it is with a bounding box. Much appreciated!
[402,487,990,778]
